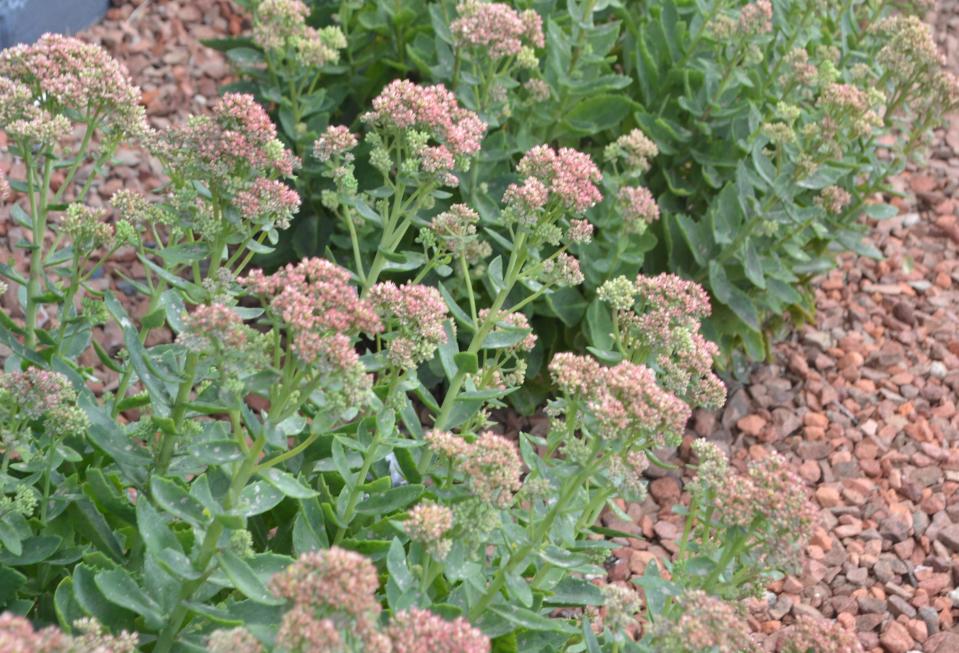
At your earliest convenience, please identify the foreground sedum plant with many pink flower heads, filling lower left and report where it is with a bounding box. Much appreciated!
[0,17,856,653]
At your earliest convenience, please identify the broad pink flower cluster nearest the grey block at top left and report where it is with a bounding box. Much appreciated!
[0,34,148,136]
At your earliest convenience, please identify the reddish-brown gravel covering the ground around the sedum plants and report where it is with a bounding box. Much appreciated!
[0,0,959,653]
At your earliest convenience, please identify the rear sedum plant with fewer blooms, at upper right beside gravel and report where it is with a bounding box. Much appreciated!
[214,0,959,370]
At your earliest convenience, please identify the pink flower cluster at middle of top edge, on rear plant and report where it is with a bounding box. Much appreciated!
[450,0,545,59]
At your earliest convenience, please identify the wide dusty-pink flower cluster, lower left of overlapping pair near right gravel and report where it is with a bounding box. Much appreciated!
[549,352,691,446]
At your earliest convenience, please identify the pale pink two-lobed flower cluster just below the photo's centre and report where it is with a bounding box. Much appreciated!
[426,431,523,508]
